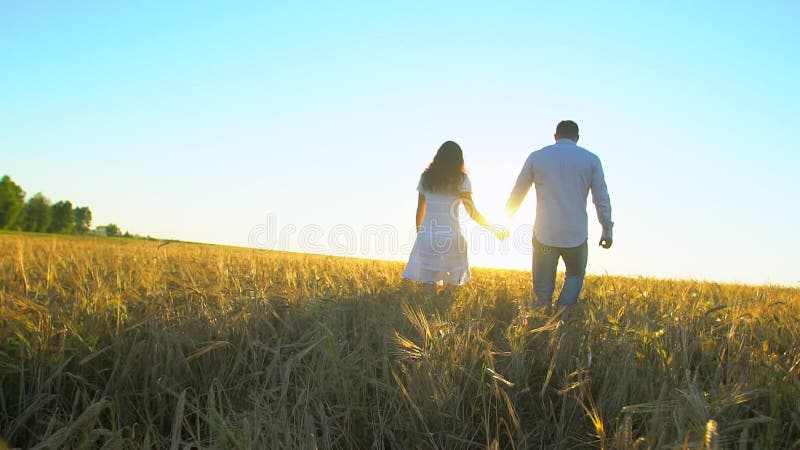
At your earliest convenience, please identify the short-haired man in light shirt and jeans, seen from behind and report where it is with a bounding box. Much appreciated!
[506,120,614,307]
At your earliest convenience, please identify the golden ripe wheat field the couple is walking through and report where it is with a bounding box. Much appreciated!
[0,234,800,449]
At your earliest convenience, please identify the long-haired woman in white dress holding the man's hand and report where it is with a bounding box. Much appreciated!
[403,141,502,291]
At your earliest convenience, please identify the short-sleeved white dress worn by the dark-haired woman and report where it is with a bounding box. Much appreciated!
[403,175,472,286]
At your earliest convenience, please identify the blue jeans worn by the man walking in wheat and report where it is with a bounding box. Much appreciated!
[531,237,589,306]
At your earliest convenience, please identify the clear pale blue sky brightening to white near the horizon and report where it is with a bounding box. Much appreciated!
[0,0,800,285]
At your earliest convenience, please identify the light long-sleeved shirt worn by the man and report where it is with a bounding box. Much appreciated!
[508,139,614,247]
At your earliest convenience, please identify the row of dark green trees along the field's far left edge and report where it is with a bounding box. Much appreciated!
[0,175,127,236]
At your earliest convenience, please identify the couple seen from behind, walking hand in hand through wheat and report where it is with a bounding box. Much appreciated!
[403,120,614,307]
